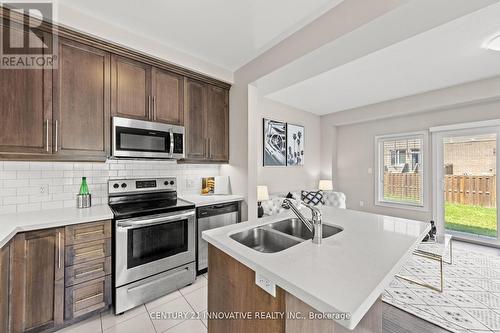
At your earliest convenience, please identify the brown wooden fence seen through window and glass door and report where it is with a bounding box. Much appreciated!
[384,173,496,207]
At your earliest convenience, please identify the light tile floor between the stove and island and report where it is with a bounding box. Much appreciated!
[57,274,208,333]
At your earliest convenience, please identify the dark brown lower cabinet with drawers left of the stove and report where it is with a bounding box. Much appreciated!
[6,220,112,333]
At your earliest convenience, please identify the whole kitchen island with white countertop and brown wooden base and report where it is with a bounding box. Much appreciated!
[203,207,430,332]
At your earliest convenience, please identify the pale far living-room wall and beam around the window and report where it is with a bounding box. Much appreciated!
[321,78,500,221]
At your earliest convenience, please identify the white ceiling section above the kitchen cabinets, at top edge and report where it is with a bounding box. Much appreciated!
[58,0,343,71]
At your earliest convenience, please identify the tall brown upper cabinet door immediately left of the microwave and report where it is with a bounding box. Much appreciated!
[54,40,110,160]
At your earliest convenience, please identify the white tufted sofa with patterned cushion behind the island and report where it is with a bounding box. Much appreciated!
[262,191,346,216]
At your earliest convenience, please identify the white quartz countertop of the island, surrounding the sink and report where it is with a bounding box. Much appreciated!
[203,206,430,329]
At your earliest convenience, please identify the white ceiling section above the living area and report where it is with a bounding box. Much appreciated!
[267,3,500,115]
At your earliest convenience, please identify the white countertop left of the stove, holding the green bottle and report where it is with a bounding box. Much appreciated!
[0,205,113,247]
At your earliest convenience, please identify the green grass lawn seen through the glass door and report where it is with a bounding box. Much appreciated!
[445,203,497,237]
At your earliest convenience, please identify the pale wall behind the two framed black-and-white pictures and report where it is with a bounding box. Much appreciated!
[255,98,321,193]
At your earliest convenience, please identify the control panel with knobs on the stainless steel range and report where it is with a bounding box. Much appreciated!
[108,177,177,194]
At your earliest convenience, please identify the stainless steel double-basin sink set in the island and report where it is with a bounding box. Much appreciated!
[229,218,343,253]
